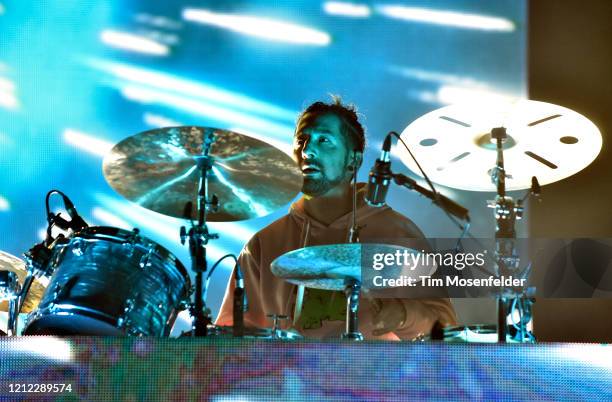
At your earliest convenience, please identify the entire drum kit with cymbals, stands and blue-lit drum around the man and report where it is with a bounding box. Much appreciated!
[0,100,602,342]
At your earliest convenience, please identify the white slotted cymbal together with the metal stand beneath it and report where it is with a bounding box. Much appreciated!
[399,99,602,342]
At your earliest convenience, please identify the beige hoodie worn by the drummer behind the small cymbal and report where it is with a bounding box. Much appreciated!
[216,186,456,340]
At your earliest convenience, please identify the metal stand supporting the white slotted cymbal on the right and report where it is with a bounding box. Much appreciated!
[489,127,539,343]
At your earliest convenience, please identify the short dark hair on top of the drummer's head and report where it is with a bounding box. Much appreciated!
[296,95,366,153]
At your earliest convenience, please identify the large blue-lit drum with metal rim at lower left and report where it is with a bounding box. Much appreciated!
[23,227,191,336]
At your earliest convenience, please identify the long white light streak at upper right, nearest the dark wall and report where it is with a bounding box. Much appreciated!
[377,5,515,32]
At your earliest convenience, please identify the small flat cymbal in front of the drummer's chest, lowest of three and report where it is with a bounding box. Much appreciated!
[270,243,436,290]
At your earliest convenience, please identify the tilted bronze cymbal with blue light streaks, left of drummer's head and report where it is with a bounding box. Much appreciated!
[103,126,302,222]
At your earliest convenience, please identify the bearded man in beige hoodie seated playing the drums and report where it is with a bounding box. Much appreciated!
[216,97,456,340]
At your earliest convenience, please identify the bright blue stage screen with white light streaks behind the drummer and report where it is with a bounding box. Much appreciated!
[0,0,526,324]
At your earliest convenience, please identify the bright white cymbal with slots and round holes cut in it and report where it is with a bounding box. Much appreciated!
[397,100,602,191]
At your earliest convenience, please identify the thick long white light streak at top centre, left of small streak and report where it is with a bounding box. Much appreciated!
[183,8,331,46]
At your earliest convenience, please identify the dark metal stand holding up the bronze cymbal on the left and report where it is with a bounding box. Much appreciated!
[180,132,219,336]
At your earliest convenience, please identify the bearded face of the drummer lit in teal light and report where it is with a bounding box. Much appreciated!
[293,113,352,197]
